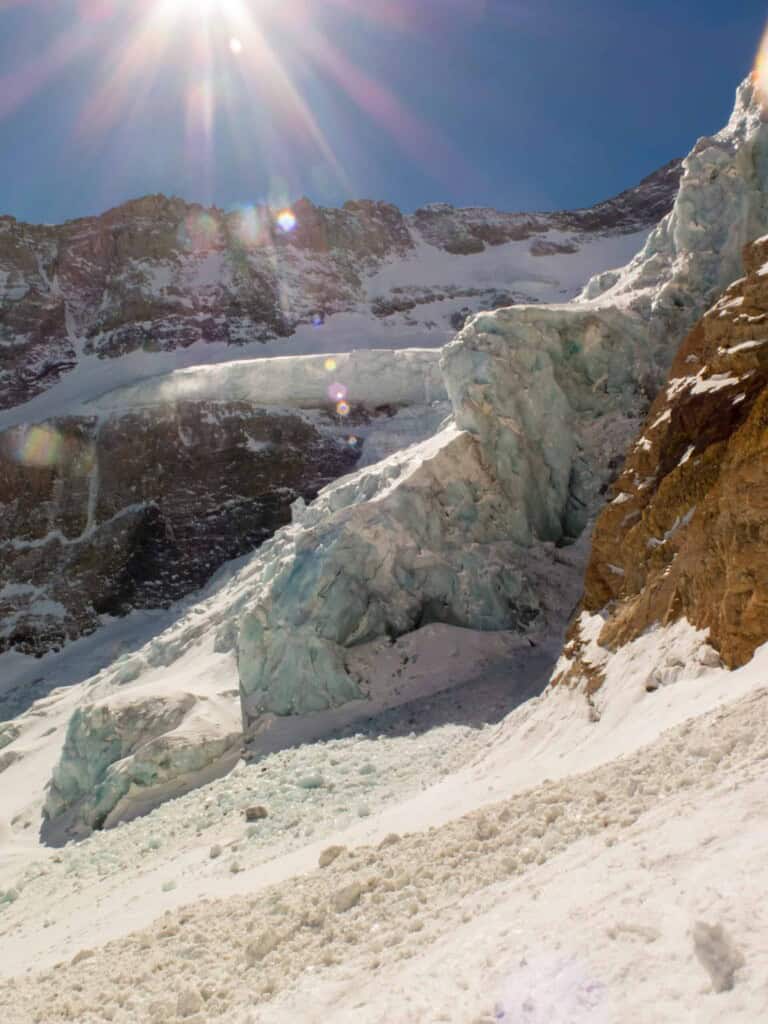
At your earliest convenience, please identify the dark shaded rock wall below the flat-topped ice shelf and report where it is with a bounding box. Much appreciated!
[0,401,359,653]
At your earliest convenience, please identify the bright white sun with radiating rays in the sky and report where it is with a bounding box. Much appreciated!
[0,0,461,206]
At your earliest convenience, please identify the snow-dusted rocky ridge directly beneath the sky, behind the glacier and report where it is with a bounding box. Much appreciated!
[0,162,680,410]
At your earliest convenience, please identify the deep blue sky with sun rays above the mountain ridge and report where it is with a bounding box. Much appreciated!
[0,0,768,222]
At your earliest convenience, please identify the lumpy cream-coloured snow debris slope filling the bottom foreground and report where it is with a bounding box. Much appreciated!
[0,658,768,1024]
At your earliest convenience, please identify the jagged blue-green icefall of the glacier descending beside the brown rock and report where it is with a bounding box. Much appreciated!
[37,75,768,835]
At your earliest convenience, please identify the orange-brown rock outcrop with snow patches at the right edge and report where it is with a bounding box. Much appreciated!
[562,239,768,690]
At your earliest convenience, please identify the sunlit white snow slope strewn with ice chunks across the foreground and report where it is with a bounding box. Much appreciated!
[0,624,768,1024]
